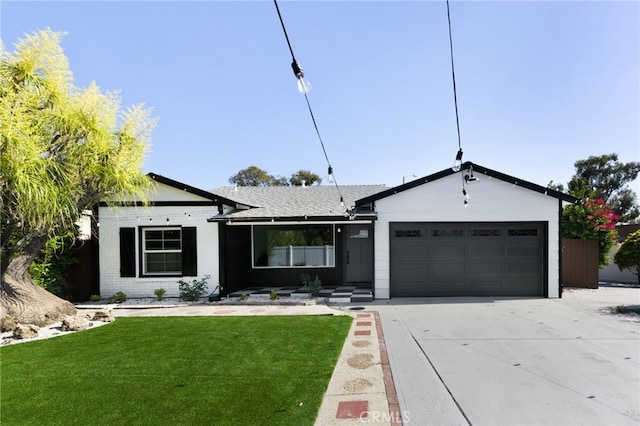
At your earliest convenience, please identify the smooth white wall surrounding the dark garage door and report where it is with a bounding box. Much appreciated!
[374,173,560,299]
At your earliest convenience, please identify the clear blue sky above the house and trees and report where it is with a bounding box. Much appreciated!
[0,0,640,192]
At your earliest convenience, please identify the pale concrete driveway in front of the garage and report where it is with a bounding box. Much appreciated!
[368,287,640,425]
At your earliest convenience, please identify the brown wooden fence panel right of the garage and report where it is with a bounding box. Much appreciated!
[562,239,599,288]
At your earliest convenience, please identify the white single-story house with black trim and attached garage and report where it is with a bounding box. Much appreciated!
[98,162,577,300]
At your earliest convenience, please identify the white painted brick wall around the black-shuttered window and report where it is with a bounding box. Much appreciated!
[98,184,220,298]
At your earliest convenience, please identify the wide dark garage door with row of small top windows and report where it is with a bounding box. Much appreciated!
[390,222,546,297]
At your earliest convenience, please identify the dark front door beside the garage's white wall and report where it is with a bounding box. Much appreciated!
[344,224,373,283]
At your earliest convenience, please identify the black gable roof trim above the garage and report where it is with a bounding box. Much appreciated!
[356,161,579,208]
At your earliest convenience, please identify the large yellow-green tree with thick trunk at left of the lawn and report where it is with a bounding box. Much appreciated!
[0,29,155,325]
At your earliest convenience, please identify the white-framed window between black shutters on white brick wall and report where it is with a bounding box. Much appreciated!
[142,227,182,275]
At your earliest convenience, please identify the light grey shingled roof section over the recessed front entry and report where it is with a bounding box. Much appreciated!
[210,185,385,221]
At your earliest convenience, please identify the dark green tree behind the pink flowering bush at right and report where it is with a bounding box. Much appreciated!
[568,153,640,223]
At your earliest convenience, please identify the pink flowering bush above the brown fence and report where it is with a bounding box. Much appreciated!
[562,198,620,267]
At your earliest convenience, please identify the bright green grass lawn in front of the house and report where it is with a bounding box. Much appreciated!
[0,316,352,426]
